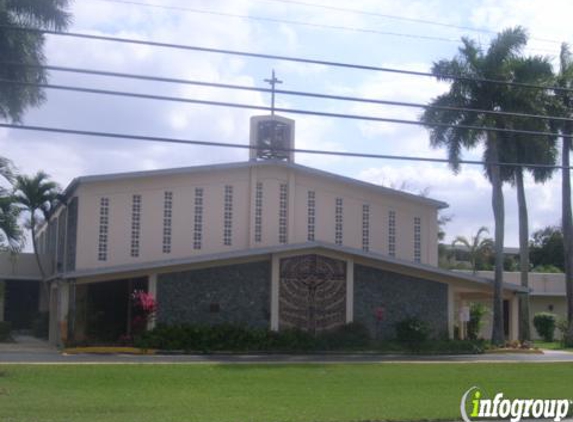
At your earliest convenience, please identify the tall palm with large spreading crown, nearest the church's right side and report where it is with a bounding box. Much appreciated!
[421,27,527,344]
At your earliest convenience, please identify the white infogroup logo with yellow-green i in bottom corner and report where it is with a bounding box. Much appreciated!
[460,386,572,422]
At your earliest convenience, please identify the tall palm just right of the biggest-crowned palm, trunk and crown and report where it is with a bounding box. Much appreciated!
[494,56,557,341]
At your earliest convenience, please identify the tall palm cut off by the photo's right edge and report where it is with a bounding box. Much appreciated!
[555,44,573,345]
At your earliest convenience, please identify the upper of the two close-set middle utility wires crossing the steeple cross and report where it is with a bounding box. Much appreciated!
[0,60,573,122]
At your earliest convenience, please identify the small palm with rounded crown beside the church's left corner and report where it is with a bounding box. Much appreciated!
[14,171,60,280]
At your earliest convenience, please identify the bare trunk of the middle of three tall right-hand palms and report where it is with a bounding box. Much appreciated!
[515,168,531,341]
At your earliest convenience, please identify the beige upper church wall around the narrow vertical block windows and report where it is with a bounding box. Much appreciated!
[52,166,437,269]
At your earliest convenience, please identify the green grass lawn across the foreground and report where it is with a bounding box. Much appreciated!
[0,363,573,422]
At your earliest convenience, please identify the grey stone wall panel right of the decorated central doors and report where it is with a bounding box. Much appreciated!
[354,265,448,339]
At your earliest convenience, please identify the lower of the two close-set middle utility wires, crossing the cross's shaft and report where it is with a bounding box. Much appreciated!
[0,79,573,139]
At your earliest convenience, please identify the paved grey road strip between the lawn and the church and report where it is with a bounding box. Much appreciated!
[0,336,573,364]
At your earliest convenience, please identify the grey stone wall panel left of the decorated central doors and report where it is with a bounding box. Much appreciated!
[157,261,271,328]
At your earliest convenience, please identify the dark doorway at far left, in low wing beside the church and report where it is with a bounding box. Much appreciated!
[4,280,40,330]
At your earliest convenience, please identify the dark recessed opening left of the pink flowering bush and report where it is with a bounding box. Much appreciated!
[86,277,147,343]
